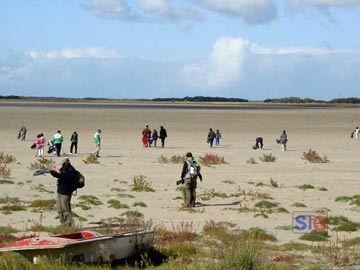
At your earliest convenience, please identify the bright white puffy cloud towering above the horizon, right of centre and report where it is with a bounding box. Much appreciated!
[181,37,248,88]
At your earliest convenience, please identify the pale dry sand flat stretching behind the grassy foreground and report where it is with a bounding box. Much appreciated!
[0,103,360,241]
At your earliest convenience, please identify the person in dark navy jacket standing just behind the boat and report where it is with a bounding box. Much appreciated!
[50,158,77,226]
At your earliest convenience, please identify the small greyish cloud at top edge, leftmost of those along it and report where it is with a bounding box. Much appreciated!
[84,0,138,20]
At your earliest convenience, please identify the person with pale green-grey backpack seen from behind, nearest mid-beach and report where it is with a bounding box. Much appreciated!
[181,152,202,208]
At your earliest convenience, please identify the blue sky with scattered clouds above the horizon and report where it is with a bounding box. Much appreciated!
[0,0,360,100]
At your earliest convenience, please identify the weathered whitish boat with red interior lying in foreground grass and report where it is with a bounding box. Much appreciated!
[0,230,154,264]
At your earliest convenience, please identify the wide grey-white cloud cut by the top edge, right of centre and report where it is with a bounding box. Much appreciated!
[193,0,277,24]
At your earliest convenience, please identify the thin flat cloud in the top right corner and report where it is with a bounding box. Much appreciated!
[287,0,360,11]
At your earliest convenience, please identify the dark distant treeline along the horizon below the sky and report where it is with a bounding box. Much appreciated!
[0,95,360,104]
